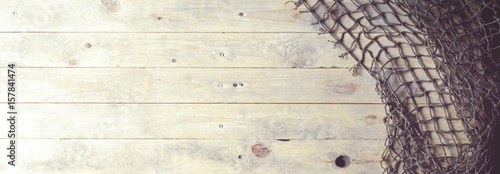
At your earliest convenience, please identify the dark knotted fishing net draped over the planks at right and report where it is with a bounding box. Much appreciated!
[296,0,500,173]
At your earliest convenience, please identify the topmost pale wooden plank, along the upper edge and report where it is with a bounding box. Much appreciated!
[0,0,319,32]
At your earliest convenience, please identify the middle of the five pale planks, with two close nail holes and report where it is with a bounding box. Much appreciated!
[0,68,380,103]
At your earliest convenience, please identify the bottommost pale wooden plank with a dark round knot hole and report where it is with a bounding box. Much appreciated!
[0,139,384,173]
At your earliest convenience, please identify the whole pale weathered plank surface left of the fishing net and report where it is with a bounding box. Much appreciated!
[0,0,394,174]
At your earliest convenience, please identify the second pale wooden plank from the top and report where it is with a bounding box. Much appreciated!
[0,33,355,68]
